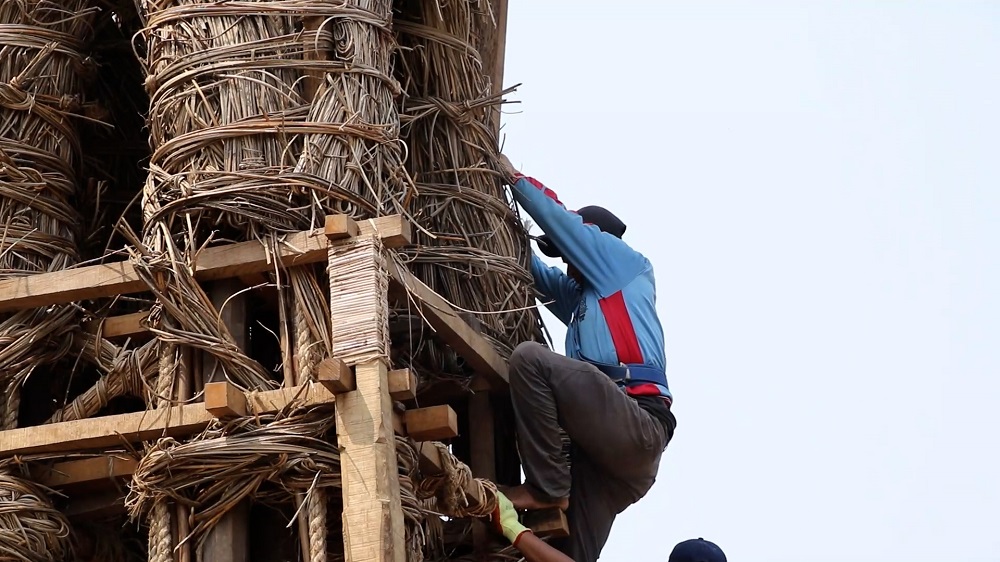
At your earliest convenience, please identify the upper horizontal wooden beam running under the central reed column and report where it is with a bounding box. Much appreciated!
[0,215,412,312]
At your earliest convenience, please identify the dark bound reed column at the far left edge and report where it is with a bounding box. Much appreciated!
[0,0,93,428]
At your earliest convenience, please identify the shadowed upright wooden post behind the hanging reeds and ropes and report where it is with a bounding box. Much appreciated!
[201,279,250,562]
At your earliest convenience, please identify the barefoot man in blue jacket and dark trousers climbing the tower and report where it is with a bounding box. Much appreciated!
[488,155,676,562]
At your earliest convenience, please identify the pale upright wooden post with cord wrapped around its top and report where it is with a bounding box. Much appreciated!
[329,237,406,562]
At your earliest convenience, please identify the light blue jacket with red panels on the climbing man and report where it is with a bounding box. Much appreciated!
[513,176,671,400]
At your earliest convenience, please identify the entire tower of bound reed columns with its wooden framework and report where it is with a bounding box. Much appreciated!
[0,0,556,562]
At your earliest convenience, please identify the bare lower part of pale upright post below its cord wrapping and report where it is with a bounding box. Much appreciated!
[337,360,406,562]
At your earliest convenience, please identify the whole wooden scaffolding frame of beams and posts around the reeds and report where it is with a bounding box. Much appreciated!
[0,215,567,561]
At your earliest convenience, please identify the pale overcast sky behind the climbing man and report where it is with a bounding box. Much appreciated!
[505,0,1000,562]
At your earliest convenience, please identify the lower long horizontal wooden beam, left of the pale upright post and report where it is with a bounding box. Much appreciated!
[0,383,334,458]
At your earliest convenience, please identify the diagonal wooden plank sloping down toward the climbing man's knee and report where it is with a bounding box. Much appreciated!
[386,260,507,384]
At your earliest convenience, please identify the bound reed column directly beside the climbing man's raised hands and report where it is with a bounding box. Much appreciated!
[395,0,541,364]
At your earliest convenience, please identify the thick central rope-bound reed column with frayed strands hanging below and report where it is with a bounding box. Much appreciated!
[133,0,412,562]
